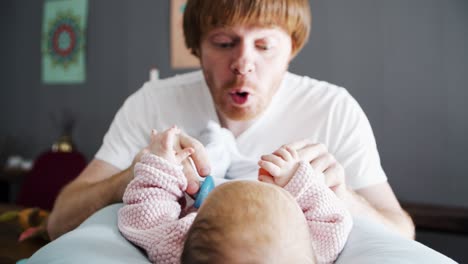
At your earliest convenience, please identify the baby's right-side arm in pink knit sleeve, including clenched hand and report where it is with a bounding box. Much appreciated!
[259,147,352,263]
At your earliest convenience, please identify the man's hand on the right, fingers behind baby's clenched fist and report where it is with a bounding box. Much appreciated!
[285,139,347,197]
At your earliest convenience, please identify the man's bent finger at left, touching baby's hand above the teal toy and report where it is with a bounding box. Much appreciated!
[179,133,211,176]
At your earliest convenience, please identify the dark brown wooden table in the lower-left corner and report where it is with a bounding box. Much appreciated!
[0,203,47,264]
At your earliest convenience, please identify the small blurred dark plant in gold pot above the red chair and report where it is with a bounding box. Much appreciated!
[52,110,75,152]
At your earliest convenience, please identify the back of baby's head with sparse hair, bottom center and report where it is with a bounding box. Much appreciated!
[181,181,314,263]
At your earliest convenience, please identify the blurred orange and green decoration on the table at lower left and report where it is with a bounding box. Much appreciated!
[0,207,50,242]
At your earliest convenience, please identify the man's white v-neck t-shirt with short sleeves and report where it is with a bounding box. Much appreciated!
[95,71,387,189]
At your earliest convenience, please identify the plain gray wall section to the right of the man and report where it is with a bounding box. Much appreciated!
[291,0,468,210]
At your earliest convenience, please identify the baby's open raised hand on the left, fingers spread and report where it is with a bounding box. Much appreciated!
[148,126,194,165]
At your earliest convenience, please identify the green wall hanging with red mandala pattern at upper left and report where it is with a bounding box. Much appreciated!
[42,0,88,84]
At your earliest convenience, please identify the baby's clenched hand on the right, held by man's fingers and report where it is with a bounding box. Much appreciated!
[258,146,300,187]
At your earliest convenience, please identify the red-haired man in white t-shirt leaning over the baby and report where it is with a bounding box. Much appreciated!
[48,0,414,239]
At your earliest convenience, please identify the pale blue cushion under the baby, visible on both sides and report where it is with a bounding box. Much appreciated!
[28,204,456,264]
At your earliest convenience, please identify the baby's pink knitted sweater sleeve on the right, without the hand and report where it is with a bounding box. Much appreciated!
[284,162,352,263]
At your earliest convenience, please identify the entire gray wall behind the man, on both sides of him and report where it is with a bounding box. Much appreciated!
[0,0,468,258]
